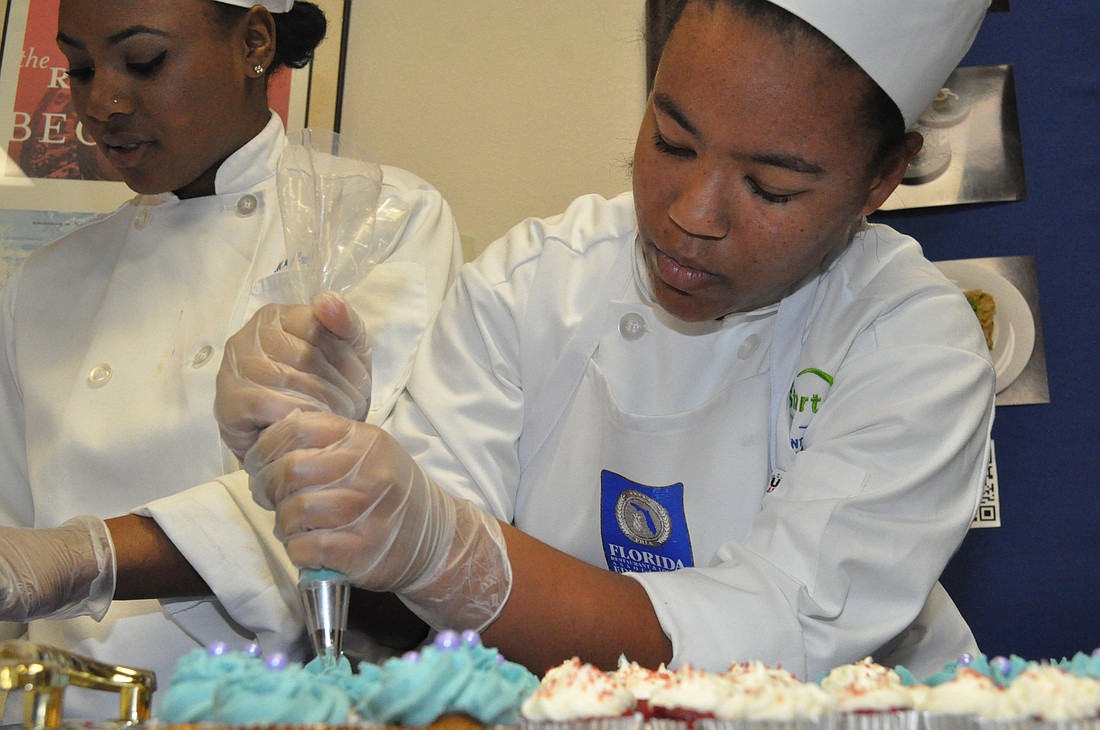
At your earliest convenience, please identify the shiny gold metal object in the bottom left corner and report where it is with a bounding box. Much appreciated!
[0,641,156,730]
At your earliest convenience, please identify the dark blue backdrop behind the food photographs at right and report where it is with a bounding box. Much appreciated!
[873,0,1100,659]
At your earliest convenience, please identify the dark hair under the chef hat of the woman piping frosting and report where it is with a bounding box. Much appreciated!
[646,0,905,169]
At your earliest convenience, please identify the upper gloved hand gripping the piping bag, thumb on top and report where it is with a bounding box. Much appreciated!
[213,292,371,458]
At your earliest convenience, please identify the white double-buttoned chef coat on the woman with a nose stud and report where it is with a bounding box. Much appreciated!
[0,114,461,719]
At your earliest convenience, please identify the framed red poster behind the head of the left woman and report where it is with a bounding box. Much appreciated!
[0,0,350,213]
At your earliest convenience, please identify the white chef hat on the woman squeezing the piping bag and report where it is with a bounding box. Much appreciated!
[770,0,990,126]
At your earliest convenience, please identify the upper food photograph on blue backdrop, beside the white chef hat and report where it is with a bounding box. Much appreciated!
[881,65,1026,210]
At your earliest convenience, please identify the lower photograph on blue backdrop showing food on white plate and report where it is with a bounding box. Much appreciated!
[935,256,1051,406]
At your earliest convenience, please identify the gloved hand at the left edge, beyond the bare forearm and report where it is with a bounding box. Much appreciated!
[0,516,114,622]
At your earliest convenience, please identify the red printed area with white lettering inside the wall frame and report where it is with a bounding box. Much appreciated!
[2,0,292,180]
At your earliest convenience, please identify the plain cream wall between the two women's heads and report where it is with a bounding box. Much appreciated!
[340,0,645,255]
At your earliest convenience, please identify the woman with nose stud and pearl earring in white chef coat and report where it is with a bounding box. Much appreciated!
[0,0,461,719]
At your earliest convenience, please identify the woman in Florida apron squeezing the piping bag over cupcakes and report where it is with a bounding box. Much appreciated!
[217,0,994,678]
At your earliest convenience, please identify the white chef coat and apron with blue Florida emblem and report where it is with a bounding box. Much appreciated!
[387,193,994,678]
